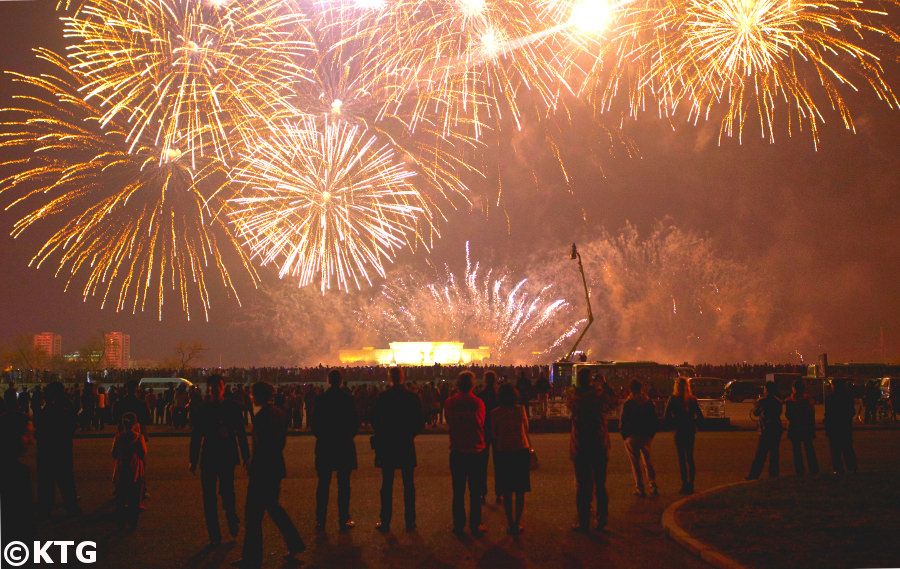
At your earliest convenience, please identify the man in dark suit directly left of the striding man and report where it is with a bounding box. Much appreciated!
[190,374,250,545]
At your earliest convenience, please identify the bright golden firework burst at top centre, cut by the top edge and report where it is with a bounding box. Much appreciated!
[366,0,584,138]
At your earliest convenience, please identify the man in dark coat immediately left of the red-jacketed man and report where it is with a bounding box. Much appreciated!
[372,367,425,533]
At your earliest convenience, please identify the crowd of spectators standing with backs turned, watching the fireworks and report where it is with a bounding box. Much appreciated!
[0,368,872,568]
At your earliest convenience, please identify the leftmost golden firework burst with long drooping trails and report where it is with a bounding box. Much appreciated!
[0,51,256,319]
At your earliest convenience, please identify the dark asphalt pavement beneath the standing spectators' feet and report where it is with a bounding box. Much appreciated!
[22,431,896,569]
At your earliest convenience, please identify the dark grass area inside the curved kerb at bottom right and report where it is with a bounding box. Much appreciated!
[676,472,900,569]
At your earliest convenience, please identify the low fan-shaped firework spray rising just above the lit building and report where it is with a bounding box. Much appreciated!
[364,245,584,361]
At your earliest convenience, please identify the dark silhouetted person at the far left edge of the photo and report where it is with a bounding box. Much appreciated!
[0,412,36,545]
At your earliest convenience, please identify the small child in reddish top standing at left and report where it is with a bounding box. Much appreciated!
[112,412,147,529]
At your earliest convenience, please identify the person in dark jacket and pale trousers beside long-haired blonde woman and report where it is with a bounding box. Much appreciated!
[619,379,659,498]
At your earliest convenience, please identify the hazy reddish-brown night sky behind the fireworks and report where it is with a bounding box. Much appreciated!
[0,0,900,365]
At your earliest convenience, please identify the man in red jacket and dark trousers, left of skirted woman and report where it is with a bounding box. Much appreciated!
[444,371,486,537]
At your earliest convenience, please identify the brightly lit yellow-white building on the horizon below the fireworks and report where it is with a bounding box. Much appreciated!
[338,342,491,365]
